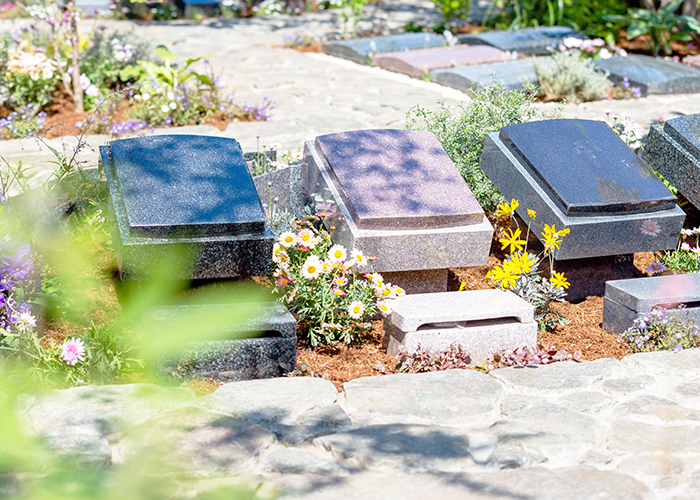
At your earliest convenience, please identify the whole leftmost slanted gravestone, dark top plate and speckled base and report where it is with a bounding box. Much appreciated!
[100,135,274,279]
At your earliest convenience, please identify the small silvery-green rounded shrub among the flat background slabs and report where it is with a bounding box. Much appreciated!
[535,52,612,103]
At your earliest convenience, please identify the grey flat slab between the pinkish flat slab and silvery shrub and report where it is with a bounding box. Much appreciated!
[432,59,539,90]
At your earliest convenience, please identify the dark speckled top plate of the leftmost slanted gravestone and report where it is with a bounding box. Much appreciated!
[109,135,266,237]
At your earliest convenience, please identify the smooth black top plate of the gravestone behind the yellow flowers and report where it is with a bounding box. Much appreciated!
[500,120,676,216]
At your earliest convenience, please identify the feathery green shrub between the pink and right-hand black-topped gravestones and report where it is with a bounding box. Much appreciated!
[406,82,558,212]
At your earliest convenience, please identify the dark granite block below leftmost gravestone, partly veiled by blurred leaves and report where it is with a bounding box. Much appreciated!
[151,302,296,382]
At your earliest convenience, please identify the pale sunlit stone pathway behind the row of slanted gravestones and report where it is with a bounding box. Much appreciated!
[0,0,700,188]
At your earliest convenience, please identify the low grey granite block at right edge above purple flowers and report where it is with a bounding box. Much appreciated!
[603,273,700,335]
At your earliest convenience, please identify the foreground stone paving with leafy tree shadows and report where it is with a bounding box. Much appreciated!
[21,349,700,500]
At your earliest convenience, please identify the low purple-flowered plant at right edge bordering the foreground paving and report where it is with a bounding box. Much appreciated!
[618,305,700,352]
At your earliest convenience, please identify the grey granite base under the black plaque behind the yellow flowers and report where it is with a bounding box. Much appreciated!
[480,132,685,261]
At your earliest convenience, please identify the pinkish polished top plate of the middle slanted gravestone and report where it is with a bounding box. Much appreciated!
[316,129,484,229]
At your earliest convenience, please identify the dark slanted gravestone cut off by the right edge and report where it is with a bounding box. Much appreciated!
[642,115,700,209]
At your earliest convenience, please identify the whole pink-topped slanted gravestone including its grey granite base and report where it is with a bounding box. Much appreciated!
[304,129,493,293]
